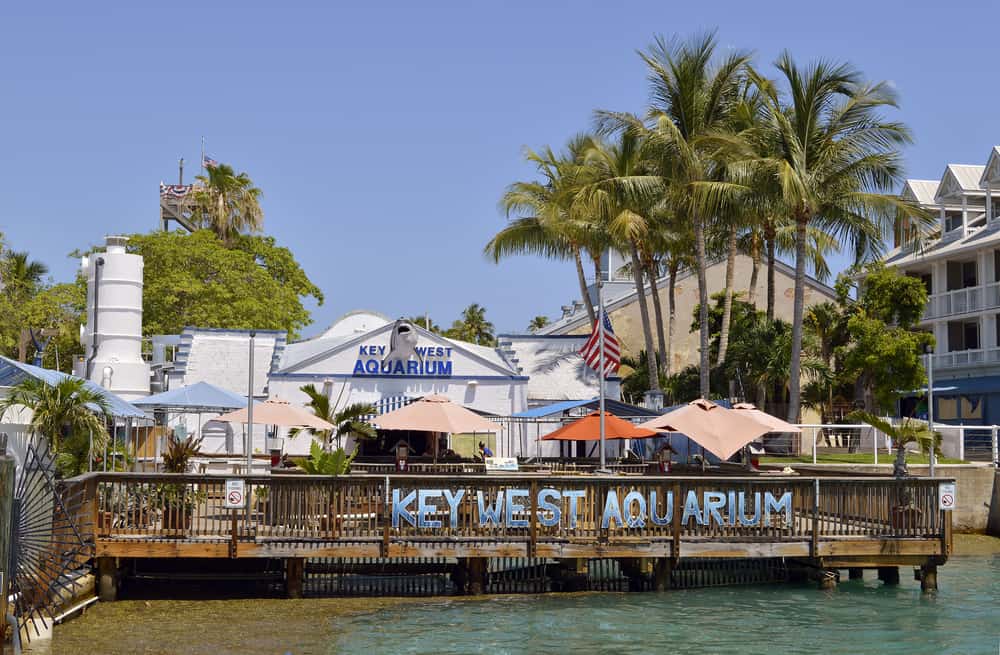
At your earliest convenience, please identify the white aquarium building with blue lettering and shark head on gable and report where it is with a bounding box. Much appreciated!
[163,310,620,455]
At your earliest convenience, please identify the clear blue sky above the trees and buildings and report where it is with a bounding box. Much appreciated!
[0,0,1000,334]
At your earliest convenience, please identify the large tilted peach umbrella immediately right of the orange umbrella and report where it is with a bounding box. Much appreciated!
[639,398,771,460]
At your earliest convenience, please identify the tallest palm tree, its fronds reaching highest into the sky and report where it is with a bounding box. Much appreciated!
[640,33,750,397]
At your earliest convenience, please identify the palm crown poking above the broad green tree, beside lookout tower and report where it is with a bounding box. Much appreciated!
[191,164,264,244]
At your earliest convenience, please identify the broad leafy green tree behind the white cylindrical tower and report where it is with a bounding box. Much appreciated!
[113,230,323,338]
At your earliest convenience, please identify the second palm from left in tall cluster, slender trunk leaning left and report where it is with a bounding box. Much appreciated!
[578,130,662,391]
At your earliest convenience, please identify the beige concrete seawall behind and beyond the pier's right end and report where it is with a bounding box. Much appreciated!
[793,464,1000,535]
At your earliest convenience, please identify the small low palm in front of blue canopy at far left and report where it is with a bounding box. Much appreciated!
[0,376,111,476]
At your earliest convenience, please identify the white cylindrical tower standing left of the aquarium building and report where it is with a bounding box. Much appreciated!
[79,236,149,400]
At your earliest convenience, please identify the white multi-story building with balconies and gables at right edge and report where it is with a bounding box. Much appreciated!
[886,146,1000,424]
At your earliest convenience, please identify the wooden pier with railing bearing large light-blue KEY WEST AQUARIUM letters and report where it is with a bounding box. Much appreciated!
[70,473,952,596]
